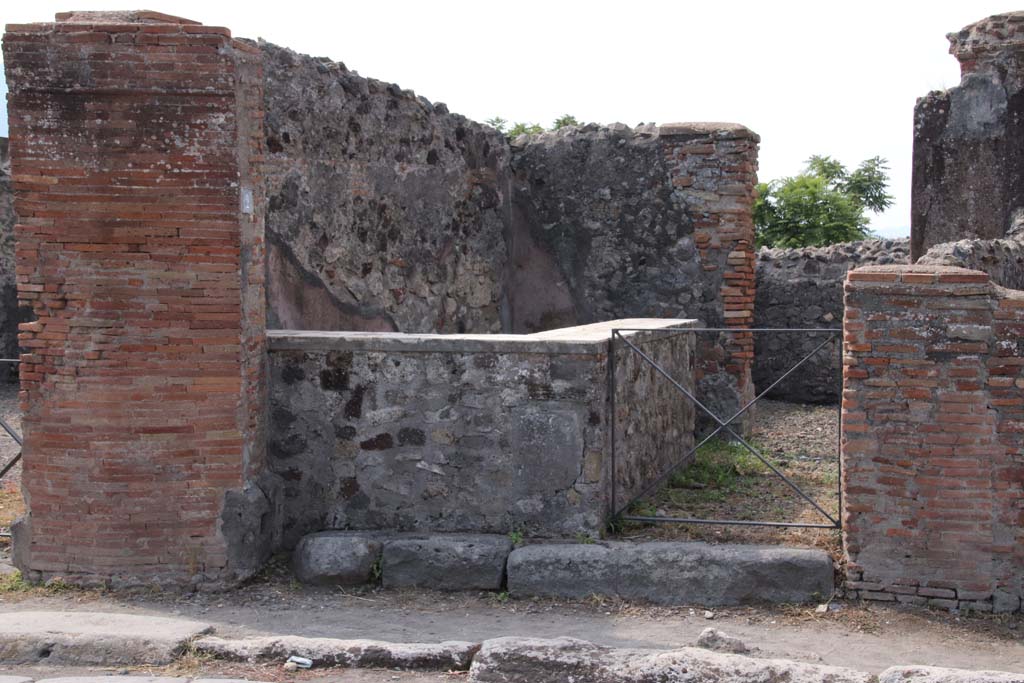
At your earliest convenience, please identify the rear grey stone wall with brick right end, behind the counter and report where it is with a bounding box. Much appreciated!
[507,124,760,428]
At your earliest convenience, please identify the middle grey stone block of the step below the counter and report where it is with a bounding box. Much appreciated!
[383,533,512,591]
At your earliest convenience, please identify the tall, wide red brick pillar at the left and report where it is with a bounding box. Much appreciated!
[3,12,273,586]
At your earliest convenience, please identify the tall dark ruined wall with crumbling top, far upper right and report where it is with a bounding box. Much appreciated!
[910,12,1024,260]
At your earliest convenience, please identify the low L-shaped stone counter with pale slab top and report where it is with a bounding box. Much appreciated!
[268,318,695,547]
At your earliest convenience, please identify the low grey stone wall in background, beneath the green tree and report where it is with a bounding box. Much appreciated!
[754,240,910,403]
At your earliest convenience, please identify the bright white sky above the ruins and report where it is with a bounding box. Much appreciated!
[0,0,1014,236]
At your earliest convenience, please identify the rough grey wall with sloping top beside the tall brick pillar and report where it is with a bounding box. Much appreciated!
[259,42,509,333]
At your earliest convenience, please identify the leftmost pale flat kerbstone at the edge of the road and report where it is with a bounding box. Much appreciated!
[0,611,212,663]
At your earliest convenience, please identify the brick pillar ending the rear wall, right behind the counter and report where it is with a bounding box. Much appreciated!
[658,123,761,430]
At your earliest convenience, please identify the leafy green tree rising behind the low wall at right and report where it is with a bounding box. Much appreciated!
[754,156,893,247]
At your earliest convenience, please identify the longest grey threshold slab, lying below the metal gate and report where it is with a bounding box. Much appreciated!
[508,543,834,606]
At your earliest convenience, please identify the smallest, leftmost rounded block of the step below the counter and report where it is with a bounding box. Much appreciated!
[292,531,382,586]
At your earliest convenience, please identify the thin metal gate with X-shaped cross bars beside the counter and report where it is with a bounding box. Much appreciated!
[609,328,843,529]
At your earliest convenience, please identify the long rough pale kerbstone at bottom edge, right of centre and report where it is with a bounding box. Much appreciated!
[469,638,874,683]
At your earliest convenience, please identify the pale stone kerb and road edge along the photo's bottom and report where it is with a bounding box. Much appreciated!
[0,610,1024,683]
